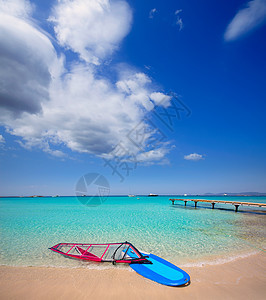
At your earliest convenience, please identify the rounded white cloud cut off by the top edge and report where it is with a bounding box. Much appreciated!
[50,0,132,65]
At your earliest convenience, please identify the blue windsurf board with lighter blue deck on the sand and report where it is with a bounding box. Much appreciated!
[127,250,190,286]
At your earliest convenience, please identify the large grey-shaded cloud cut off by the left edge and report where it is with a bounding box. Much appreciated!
[0,1,57,115]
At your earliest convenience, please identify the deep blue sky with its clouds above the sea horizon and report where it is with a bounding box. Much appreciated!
[0,0,266,195]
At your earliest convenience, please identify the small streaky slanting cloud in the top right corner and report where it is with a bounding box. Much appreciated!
[224,0,266,41]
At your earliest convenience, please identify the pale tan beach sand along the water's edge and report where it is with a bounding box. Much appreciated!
[0,252,266,300]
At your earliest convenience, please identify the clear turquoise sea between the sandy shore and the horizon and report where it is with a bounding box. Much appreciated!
[0,196,266,268]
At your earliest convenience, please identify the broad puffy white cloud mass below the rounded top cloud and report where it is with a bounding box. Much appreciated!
[7,65,170,156]
